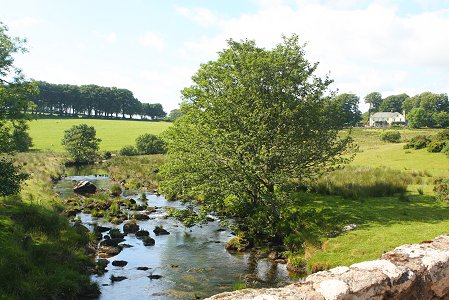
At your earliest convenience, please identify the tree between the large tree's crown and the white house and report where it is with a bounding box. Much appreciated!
[334,94,362,126]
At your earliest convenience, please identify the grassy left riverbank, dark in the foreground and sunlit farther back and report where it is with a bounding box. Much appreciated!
[0,153,99,299]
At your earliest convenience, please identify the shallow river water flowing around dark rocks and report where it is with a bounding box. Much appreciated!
[55,176,290,299]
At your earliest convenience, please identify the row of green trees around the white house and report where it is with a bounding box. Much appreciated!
[333,92,449,128]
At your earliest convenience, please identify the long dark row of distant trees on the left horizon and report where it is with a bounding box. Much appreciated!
[32,81,167,120]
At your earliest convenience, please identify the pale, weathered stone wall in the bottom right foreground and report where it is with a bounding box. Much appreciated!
[208,235,449,300]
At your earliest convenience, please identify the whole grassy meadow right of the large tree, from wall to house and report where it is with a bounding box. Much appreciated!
[297,129,449,270]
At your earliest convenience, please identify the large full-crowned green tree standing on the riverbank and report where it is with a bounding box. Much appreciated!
[161,35,351,243]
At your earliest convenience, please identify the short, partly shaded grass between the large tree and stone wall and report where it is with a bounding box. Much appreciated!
[298,195,449,268]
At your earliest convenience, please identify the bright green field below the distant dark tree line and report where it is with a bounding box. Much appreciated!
[29,119,171,152]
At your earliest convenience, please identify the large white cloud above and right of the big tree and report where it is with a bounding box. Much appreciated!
[180,0,449,111]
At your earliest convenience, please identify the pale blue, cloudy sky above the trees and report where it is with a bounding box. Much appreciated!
[0,0,449,112]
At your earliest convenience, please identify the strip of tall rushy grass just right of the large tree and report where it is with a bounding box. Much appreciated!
[310,166,414,199]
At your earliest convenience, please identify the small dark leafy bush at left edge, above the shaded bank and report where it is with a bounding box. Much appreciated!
[0,158,29,196]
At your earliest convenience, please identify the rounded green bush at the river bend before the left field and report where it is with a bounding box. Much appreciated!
[61,124,101,163]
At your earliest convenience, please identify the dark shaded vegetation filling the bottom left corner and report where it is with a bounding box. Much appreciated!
[0,201,99,299]
